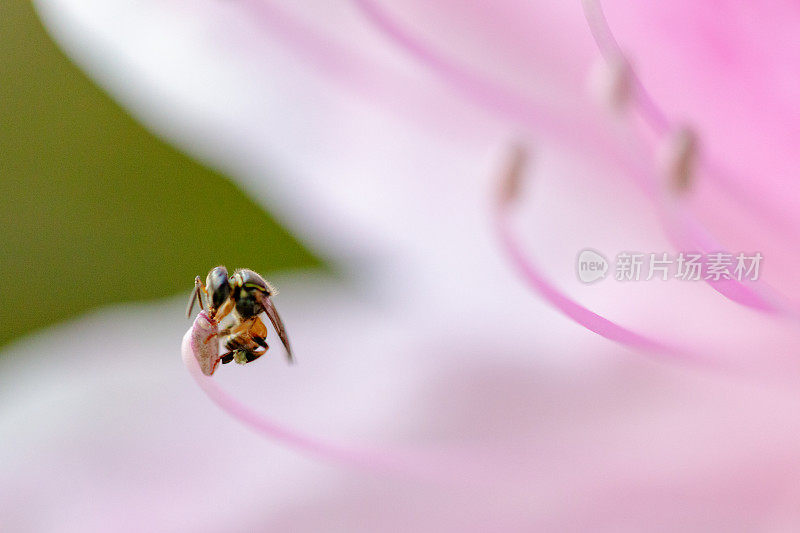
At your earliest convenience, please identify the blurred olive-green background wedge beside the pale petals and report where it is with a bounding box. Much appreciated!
[0,0,320,346]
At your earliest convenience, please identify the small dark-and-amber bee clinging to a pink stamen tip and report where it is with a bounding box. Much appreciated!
[186,266,294,372]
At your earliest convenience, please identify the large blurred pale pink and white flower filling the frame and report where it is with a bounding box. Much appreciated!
[0,0,800,531]
